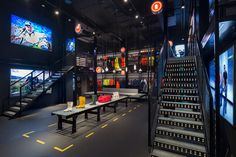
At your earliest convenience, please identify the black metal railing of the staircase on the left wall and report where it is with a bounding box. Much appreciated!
[2,53,75,114]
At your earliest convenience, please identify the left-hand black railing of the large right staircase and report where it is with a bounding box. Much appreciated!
[148,39,170,148]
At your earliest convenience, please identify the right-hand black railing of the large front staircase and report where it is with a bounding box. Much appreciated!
[189,36,214,156]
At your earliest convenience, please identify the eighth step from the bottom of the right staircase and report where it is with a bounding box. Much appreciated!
[161,88,198,95]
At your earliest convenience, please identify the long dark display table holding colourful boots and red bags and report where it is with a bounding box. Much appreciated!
[52,96,128,133]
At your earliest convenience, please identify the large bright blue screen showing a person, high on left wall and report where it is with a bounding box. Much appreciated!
[11,15,52,51]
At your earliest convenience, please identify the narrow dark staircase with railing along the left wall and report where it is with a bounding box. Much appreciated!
[2,54,75,119]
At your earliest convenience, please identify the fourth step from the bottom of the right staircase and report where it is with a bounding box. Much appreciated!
[158,117,203,131]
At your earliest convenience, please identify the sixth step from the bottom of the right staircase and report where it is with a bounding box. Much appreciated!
[161,101,201,111]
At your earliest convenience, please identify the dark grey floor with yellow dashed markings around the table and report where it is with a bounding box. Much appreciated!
[0,102,149,157]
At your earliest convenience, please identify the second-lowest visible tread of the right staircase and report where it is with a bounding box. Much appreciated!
[155,137,206,153]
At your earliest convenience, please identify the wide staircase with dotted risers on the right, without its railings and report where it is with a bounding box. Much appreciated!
[151,57,208,157]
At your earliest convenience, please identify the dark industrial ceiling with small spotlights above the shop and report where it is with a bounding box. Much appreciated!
[21,0,190,49]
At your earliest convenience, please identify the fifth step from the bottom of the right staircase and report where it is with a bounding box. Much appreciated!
[160,109,202,121]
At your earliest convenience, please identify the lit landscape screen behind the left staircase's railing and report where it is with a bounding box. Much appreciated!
[10,69,49,96]
